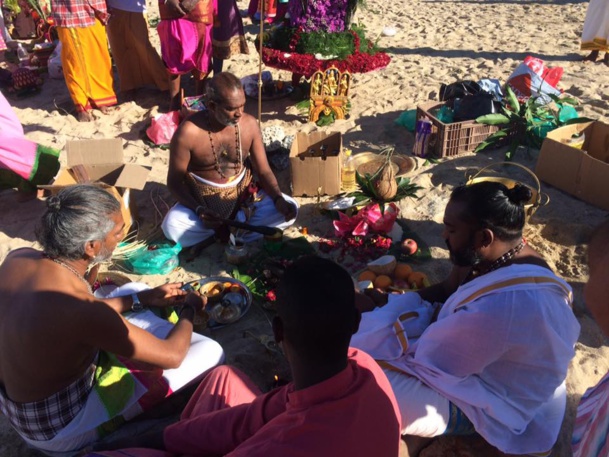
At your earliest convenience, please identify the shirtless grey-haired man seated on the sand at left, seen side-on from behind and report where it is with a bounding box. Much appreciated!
[0,185,223,452]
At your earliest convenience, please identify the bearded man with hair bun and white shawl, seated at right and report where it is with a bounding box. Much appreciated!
[351,182,579,455]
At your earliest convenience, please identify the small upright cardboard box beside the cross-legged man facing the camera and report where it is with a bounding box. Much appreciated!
[290,131,343,197]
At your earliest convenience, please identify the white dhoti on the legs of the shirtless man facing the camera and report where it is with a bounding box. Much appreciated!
[161,192,298,248]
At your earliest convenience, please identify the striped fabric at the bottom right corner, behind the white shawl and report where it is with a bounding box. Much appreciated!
[571,373,609,457]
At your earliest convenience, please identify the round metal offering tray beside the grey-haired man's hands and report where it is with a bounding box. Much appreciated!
[183,276,253,328]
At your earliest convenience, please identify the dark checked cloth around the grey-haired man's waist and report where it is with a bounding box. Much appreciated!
[0,364,96,441]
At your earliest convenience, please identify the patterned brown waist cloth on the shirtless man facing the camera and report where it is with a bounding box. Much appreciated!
[186,167,252,219]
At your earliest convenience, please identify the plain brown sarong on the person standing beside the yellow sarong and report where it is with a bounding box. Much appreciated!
[107,8,169,92]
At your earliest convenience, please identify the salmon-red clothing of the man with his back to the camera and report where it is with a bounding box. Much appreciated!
[163,349,400,457]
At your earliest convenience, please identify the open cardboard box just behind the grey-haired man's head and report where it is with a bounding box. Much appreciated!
[38,138,150,234]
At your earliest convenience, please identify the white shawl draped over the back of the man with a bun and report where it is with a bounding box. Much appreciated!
[351,264,579,454]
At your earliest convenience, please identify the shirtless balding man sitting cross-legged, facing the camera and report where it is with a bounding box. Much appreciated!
[162,72,298,247]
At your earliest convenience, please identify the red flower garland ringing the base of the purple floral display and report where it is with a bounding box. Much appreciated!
[262,28,391,78]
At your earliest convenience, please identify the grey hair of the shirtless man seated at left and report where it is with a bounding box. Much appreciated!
[36,184,121,260]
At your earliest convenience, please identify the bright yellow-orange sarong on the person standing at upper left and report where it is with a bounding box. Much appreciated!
[57,19,116,111]
